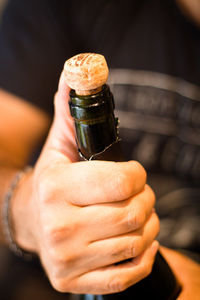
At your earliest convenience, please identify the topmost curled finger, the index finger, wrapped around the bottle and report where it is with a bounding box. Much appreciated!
[46,161,146,206]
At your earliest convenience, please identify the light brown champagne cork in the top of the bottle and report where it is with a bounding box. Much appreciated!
[64,53,109,95]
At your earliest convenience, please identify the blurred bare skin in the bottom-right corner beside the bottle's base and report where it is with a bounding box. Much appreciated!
[161,247,200,300]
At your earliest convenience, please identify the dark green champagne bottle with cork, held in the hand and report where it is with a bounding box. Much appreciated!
[64,53,180,300]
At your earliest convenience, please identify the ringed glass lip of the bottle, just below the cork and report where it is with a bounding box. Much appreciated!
[70,84,110,107]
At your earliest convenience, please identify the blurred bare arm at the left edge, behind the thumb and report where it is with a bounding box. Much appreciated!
[0,90,50,242]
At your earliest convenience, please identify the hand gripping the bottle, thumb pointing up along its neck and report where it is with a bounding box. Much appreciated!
[12,69,159,294]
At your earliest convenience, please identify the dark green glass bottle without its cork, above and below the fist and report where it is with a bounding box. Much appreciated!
[69,85,180,300]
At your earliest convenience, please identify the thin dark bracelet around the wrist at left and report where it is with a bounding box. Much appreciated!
[2,166,34,260]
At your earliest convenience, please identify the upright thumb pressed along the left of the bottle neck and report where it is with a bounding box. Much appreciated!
[39,72,79,162]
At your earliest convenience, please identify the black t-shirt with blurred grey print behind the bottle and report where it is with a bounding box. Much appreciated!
[0,0,200,255]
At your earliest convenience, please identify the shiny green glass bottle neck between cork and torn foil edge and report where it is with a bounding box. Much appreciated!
[69,85,118,160]
